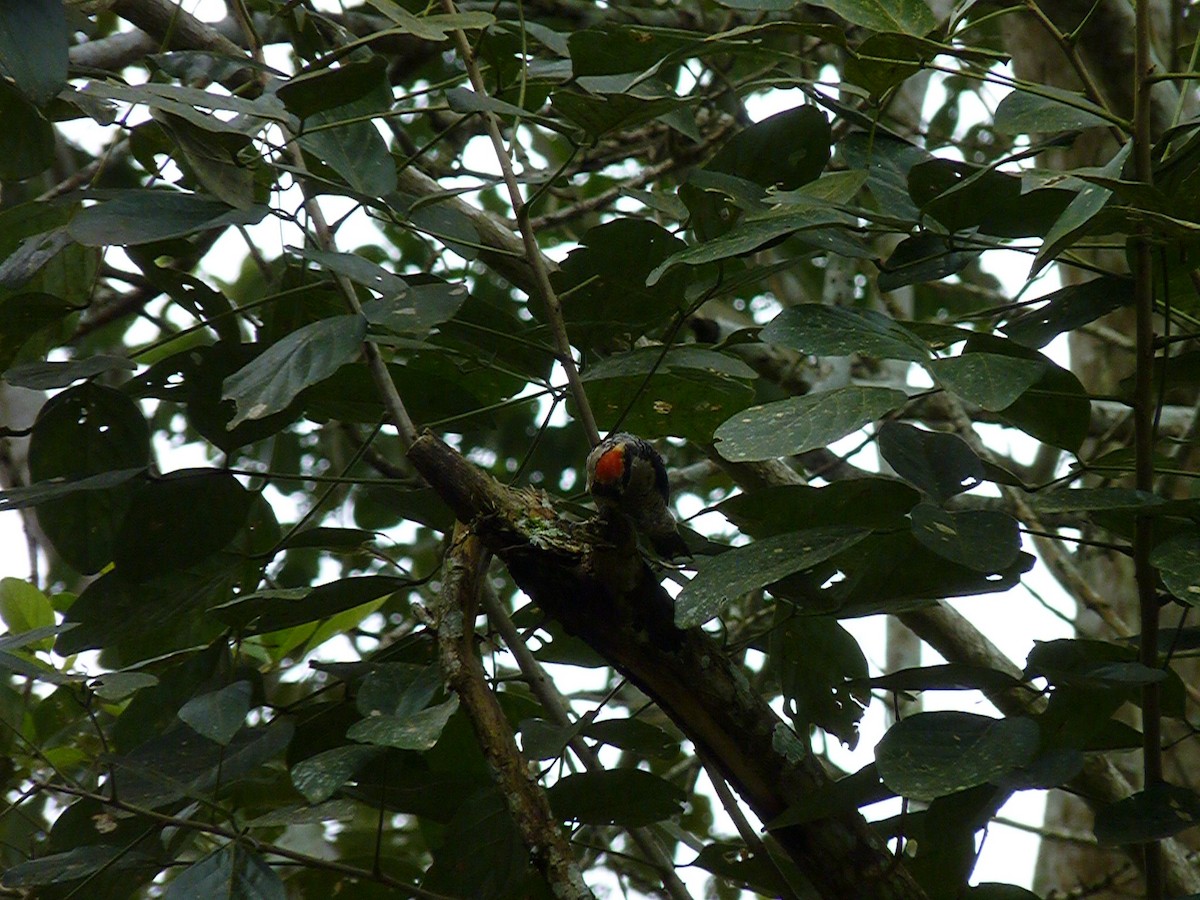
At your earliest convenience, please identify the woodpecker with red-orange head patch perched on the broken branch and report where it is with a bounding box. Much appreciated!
[587,432,691,559]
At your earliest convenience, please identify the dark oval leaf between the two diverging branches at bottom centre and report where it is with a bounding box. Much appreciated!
[546,769,685,828]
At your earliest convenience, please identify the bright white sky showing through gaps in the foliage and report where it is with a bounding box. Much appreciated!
[0,4,1099,896]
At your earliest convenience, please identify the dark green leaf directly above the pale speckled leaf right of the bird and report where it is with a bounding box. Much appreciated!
[758,304,929,362]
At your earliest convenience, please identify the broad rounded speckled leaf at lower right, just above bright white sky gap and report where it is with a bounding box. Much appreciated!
[875,712,1042,802]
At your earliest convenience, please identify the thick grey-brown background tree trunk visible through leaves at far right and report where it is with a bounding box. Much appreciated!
[1006,0,1200,900]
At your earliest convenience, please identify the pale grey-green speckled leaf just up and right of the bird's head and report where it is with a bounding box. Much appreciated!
[714,385,907,462]
